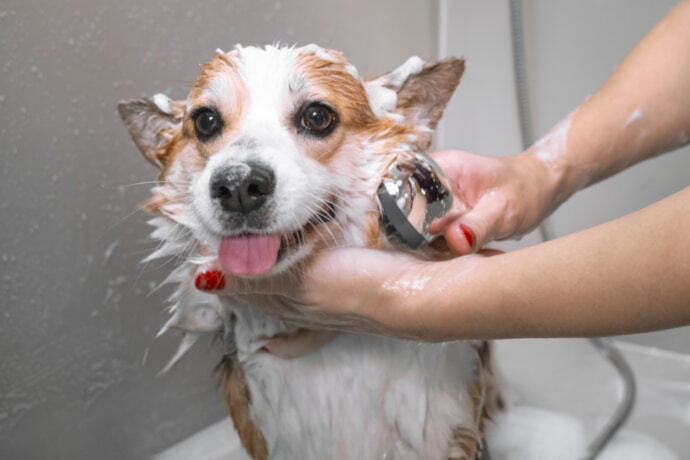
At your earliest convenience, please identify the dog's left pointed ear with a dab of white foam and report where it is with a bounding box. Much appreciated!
[117,94,185,168]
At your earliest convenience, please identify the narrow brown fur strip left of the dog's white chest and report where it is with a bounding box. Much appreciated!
[224,360,268,460]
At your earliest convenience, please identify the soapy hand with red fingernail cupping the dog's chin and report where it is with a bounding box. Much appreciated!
[196,248,430,337]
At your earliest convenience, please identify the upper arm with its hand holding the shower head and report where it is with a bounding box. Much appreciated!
[434,1,690,254]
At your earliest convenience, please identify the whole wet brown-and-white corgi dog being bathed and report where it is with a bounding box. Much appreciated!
[118,45,502,460]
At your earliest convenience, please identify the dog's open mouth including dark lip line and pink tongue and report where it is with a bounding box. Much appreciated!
[218,200,335,276]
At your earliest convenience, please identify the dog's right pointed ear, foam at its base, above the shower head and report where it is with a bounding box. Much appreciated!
[366,56,465,135]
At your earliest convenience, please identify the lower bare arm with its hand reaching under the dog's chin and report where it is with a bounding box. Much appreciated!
[264,187,690,341]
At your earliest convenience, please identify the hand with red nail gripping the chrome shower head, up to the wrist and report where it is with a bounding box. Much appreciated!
[430,150,565,254]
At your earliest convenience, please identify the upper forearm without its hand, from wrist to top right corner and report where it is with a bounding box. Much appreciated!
[530,1,690,204]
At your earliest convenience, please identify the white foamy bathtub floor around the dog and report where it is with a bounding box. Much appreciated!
[154,339,690,460]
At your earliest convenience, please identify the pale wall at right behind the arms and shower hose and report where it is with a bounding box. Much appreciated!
[439,0,690,353]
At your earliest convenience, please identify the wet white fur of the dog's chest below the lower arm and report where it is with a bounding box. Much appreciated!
[240,328,477,460]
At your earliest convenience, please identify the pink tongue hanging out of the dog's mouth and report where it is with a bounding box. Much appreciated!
[218,236,280,276]
